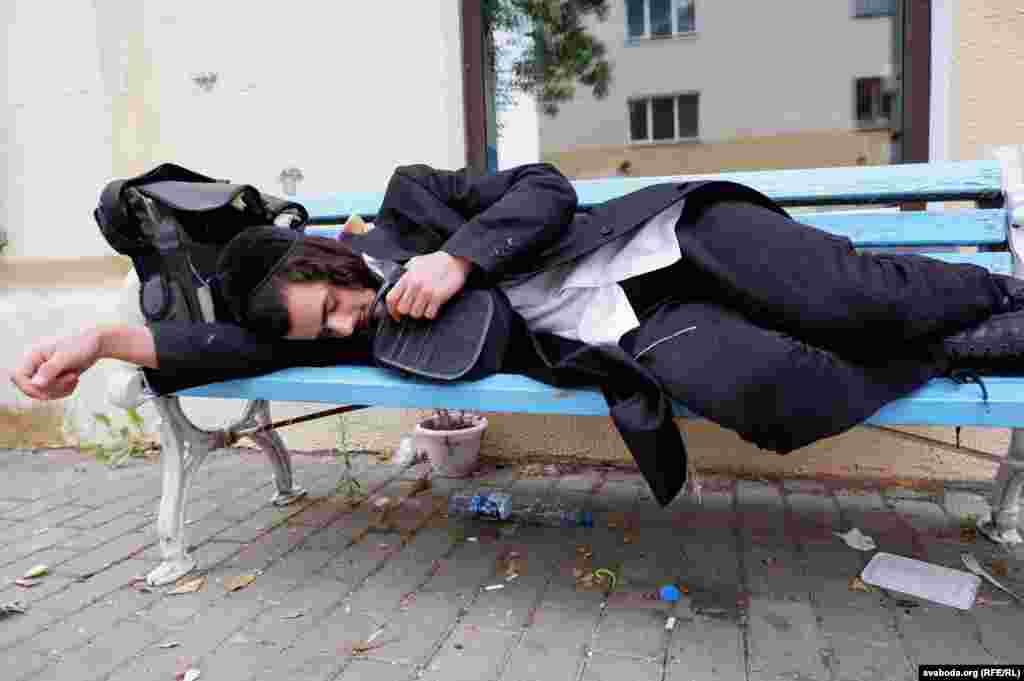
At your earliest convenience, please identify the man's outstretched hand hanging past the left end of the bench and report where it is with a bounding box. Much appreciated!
[10,330,101,399]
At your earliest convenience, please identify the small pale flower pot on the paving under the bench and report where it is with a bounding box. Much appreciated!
[414,413,487,477]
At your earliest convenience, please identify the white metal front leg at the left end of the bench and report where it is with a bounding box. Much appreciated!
[145,396,227,586]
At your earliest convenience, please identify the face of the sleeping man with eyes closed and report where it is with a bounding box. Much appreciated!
[284,282,384,339]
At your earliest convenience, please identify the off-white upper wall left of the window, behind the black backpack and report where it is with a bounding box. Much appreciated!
[0,0,465,256]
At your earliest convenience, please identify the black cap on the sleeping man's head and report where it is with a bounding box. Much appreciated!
[217,226,302,326]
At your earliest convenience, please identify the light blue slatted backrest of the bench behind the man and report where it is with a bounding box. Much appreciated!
[299,161,1014,273]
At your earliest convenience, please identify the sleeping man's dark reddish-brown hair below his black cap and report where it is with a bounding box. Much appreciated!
[246,235,383,336]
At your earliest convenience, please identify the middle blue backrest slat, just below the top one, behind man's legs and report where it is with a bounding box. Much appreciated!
[794,209,1007,246]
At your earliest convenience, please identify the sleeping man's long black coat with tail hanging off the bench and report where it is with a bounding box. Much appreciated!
[147,164,785,504]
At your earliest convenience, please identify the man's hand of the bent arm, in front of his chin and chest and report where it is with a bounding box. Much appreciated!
[385,251,473,322]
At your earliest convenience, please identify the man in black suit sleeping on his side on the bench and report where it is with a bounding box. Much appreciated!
[12,164,1024,504]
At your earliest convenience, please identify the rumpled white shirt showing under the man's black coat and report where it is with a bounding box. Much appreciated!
[362,196,684,345]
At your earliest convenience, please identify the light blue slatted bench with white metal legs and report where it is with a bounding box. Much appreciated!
[113,148,1024,584]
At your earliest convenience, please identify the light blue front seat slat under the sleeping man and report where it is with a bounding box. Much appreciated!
[178,367,1024,427]
